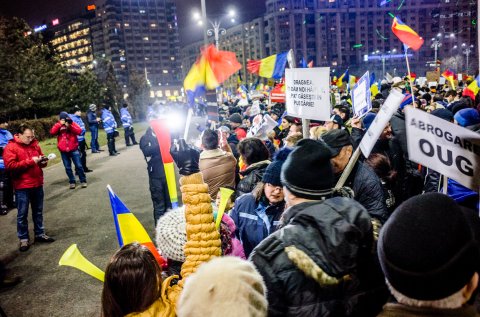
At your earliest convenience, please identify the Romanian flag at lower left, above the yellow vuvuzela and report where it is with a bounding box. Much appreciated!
[107,185,167,267]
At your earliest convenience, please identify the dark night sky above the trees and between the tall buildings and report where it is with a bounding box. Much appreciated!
[0,0,265,43]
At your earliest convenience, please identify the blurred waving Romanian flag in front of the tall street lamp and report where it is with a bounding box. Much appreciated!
[183,44,242,103]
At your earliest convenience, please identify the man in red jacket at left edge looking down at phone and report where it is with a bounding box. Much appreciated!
[3,125,55,252]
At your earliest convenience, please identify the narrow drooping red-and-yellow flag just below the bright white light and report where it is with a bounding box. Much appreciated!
[150,119,178,208]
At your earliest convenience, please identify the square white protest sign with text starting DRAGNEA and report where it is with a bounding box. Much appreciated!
[285,67,331,121]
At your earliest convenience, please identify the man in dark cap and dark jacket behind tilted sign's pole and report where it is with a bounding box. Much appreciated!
[322,130,388,223]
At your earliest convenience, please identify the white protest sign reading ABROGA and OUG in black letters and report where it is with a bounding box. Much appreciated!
[405,107,480,191]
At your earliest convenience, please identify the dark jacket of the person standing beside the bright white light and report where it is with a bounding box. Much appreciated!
[140,127,166,179]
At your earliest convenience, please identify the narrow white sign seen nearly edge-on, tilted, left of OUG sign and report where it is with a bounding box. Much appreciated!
[360,89,405,157]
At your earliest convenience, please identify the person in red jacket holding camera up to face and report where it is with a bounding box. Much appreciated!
[50,112,87,189]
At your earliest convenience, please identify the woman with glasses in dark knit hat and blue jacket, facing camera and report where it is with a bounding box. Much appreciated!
[230,149,291,257]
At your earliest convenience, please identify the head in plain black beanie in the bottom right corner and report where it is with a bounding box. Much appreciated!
[378,193,480,317]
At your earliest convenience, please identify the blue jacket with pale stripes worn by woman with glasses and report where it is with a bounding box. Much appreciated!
[230,193,285,257]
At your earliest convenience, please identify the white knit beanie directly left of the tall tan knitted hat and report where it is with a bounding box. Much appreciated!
[155,207,187,262]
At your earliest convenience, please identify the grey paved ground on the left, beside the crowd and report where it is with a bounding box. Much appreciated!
[0,118,201,317]
